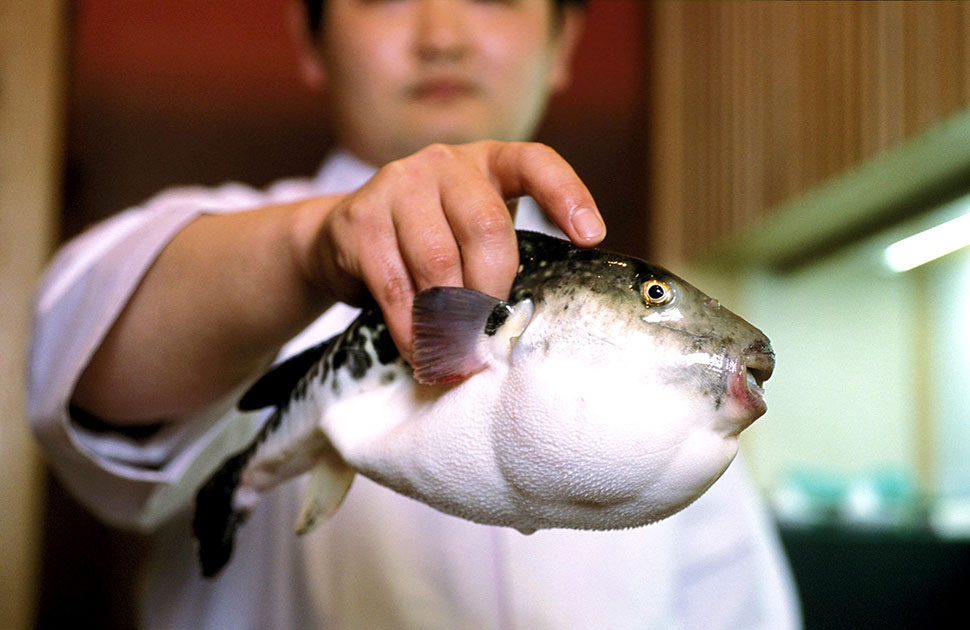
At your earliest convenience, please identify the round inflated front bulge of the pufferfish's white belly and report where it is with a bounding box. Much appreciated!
[493,352,737,529]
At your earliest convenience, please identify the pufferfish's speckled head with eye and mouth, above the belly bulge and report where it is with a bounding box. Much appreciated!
[512,236,775,435]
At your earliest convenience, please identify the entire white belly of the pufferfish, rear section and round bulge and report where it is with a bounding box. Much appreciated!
[322,334,737,531]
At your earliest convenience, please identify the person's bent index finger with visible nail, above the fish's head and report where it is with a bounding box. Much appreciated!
[489,142,606,247]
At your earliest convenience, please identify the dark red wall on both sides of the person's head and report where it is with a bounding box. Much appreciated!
[65,0,645,253]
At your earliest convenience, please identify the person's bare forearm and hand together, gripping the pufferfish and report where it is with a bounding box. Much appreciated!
[73,141,605,423]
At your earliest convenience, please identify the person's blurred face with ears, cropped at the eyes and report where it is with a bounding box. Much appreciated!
[319,0,582,165]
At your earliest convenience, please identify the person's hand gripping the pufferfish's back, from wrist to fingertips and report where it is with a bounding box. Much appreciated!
[294,140,606,359]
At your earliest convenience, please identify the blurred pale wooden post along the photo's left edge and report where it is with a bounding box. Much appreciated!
[0,0,67,628]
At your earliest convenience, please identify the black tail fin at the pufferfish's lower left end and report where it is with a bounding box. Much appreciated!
[192,449,252,577]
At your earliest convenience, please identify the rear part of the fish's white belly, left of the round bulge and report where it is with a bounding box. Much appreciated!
[321,368,514,525]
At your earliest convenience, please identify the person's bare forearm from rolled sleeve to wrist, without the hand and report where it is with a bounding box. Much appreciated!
[73,197,339,424]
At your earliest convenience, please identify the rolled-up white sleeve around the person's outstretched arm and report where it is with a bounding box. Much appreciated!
[27,185,265,529]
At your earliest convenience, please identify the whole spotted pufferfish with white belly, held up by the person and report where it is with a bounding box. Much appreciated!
[193,231,774,575]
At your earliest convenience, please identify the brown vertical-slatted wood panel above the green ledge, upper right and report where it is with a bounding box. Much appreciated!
[648,2,970,261]
